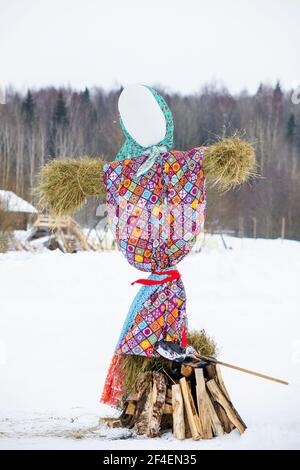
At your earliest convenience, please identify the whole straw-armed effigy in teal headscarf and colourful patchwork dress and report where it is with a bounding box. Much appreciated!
[40,85,255,406]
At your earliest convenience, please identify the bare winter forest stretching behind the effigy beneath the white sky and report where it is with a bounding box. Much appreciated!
[0,83,300,239]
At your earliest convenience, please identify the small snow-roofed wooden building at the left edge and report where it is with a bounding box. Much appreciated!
[0,190,38,231]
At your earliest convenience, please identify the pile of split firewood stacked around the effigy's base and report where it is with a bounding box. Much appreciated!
[101,365,246,440]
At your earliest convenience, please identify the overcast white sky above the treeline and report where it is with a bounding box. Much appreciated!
[0,0,300,93]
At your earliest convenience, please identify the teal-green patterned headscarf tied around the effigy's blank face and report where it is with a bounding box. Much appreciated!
[116,85,174,164]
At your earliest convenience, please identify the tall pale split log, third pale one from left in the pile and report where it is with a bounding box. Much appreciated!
[195,369,213,439]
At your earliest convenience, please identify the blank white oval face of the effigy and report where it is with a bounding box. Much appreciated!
[118,85,167,147]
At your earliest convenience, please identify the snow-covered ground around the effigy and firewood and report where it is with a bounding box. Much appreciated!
[0,238,300,449]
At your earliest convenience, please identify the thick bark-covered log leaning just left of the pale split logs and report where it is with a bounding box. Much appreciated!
[147,372,167,437]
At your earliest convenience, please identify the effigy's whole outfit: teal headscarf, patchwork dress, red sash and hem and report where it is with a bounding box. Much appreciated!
[101,89,206,406]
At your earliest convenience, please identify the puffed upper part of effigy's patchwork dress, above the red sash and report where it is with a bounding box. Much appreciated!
[104,147,206,272]
